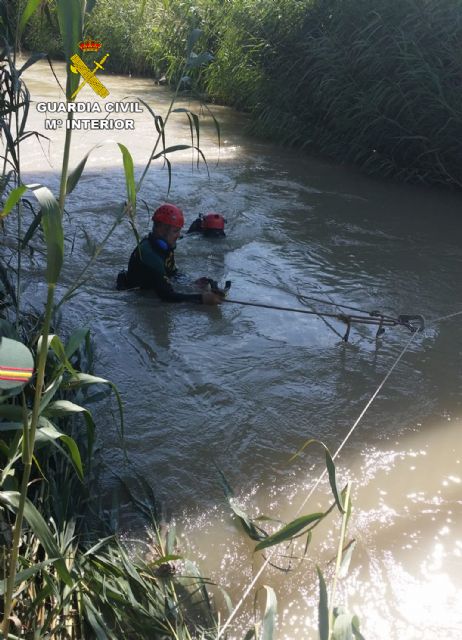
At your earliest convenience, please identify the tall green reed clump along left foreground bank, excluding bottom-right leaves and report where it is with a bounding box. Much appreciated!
[0,0,224,640]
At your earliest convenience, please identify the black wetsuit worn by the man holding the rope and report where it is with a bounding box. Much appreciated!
[118,233,202,304]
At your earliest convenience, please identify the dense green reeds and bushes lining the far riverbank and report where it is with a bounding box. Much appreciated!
[13,0,462,188]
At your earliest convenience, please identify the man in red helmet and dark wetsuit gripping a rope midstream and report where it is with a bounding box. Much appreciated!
[117,203,223,305]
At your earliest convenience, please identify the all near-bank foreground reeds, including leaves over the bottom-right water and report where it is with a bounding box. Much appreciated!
[0,0,362,640]
